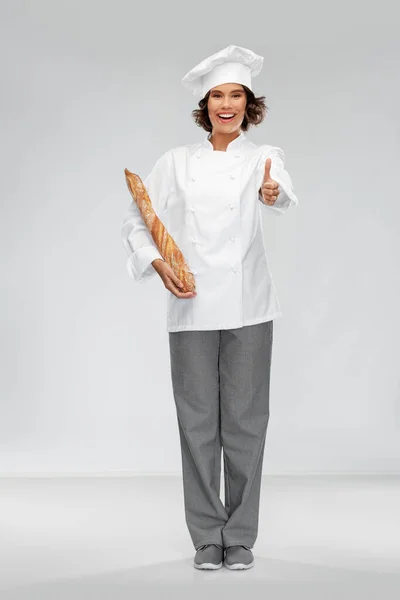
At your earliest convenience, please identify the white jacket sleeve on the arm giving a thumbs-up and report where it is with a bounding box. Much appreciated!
[256,146,299,215]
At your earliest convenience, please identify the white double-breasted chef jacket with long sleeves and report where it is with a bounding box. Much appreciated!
[121,131,298,332]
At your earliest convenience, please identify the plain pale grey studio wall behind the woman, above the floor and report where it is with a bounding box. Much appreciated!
[0,0,400,475]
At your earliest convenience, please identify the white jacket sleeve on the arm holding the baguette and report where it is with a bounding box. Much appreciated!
[121,150,173,283]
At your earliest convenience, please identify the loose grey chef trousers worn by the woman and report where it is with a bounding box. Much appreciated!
[169,321,273,550]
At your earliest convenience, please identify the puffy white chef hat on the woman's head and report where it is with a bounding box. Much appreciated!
[181,45,264,98]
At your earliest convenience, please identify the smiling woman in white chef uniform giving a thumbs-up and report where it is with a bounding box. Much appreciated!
[122,45,298,569]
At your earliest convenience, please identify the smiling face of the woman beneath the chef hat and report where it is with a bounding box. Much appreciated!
[207,83,247,134]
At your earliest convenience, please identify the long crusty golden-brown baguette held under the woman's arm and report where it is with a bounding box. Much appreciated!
[125,169,196,292]
